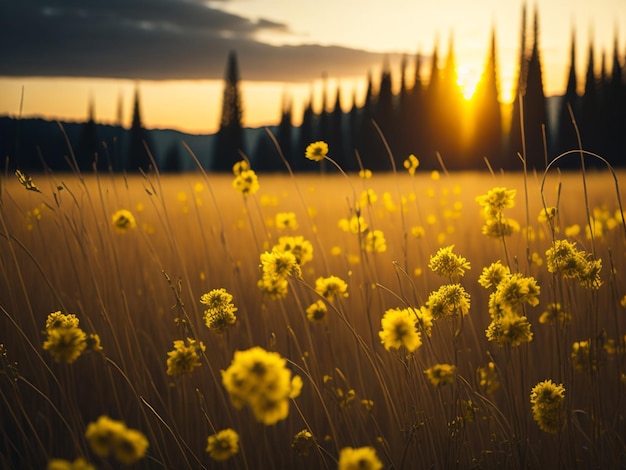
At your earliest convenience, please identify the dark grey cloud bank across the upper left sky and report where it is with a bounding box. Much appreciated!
[0,0,394,81]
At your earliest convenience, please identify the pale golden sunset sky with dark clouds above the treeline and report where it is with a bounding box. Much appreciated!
[0,0,626,133]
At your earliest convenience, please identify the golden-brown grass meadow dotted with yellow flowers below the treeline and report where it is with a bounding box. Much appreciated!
[0,156,626,469]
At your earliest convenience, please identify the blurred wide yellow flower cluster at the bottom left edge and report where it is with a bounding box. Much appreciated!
[85,415,149,465]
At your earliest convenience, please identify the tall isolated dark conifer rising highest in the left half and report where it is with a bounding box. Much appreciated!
[211,51,245,171]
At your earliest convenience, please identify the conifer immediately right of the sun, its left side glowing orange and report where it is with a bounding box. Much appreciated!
[467,29,504,169]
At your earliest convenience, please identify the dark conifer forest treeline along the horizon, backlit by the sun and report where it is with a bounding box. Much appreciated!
[0,6,626,172]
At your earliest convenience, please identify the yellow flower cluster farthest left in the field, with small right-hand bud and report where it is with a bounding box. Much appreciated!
[43,311,102,364]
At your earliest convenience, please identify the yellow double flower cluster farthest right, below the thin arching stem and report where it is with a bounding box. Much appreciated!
[546,240,602,289]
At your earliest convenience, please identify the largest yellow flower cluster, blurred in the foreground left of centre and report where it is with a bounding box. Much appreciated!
[222,346,302,425]
